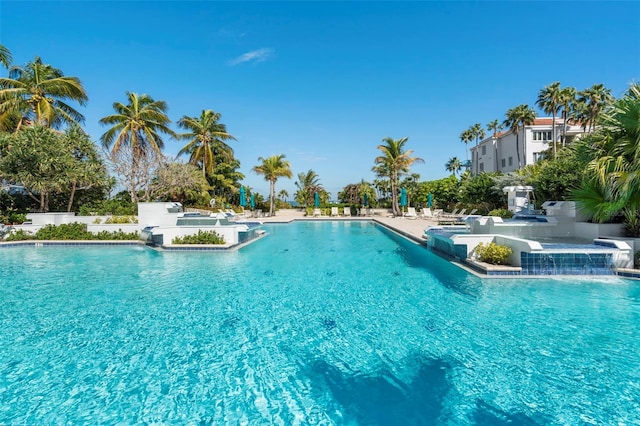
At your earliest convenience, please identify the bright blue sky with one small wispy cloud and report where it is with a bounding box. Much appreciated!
[0,0,640,198]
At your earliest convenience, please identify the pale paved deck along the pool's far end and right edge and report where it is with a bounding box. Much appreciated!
[255,209,438,241]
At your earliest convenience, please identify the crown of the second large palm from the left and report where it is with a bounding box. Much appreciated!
[100,92,176,162]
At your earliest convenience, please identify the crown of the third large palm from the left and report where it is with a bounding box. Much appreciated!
[178,109,236,176]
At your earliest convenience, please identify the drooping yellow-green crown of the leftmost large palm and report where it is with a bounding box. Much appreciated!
[0,54,88,130]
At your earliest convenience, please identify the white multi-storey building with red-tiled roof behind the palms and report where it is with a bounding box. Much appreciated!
[470,117,584,174]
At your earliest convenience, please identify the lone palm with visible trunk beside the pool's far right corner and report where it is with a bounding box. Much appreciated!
[373,137,424,216]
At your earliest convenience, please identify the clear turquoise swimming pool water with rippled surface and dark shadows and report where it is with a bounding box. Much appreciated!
[0,222,640,425]
